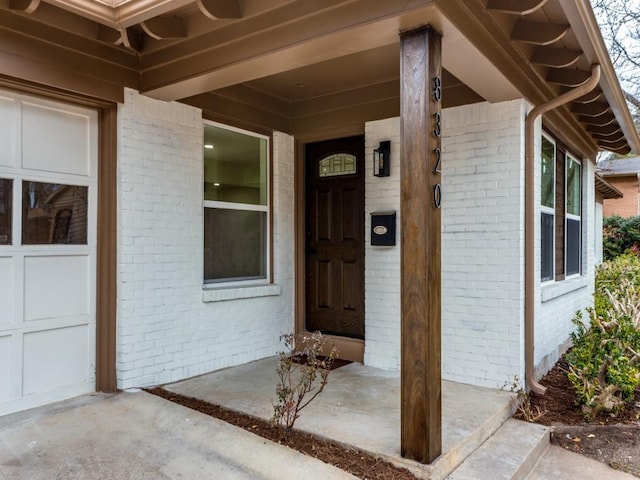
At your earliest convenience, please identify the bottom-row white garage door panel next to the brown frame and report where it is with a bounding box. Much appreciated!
[22,325,90,396]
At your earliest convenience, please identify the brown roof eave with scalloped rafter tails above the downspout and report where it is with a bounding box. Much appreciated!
[437,0,640,154]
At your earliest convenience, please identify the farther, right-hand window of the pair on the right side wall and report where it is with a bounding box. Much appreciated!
[565,155,582,275]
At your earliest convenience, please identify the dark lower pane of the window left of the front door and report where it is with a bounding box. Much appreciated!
[204,208,267,282]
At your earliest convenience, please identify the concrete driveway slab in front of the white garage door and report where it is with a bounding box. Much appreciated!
[0,392,355,480]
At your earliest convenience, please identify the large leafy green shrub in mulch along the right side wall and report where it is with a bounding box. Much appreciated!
[566,255,640,418]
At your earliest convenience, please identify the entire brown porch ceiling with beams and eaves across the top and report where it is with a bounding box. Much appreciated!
[0,0,640,155]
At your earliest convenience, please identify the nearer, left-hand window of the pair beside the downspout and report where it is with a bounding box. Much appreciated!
[540,135,556,282]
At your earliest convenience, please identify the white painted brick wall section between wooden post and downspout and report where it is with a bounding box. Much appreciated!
[442,100,525,388]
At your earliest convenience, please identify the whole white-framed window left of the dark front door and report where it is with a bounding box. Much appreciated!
[203,122,269,283]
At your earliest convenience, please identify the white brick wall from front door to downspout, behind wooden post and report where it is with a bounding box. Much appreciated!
[365,101,524,387]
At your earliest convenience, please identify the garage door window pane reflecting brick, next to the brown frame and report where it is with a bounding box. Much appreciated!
[22,181,88,245]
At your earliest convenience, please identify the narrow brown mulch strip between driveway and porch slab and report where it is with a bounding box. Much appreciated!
[146,387,416,480]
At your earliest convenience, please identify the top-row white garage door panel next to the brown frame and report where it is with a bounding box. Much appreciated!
[22,102,91,175]
